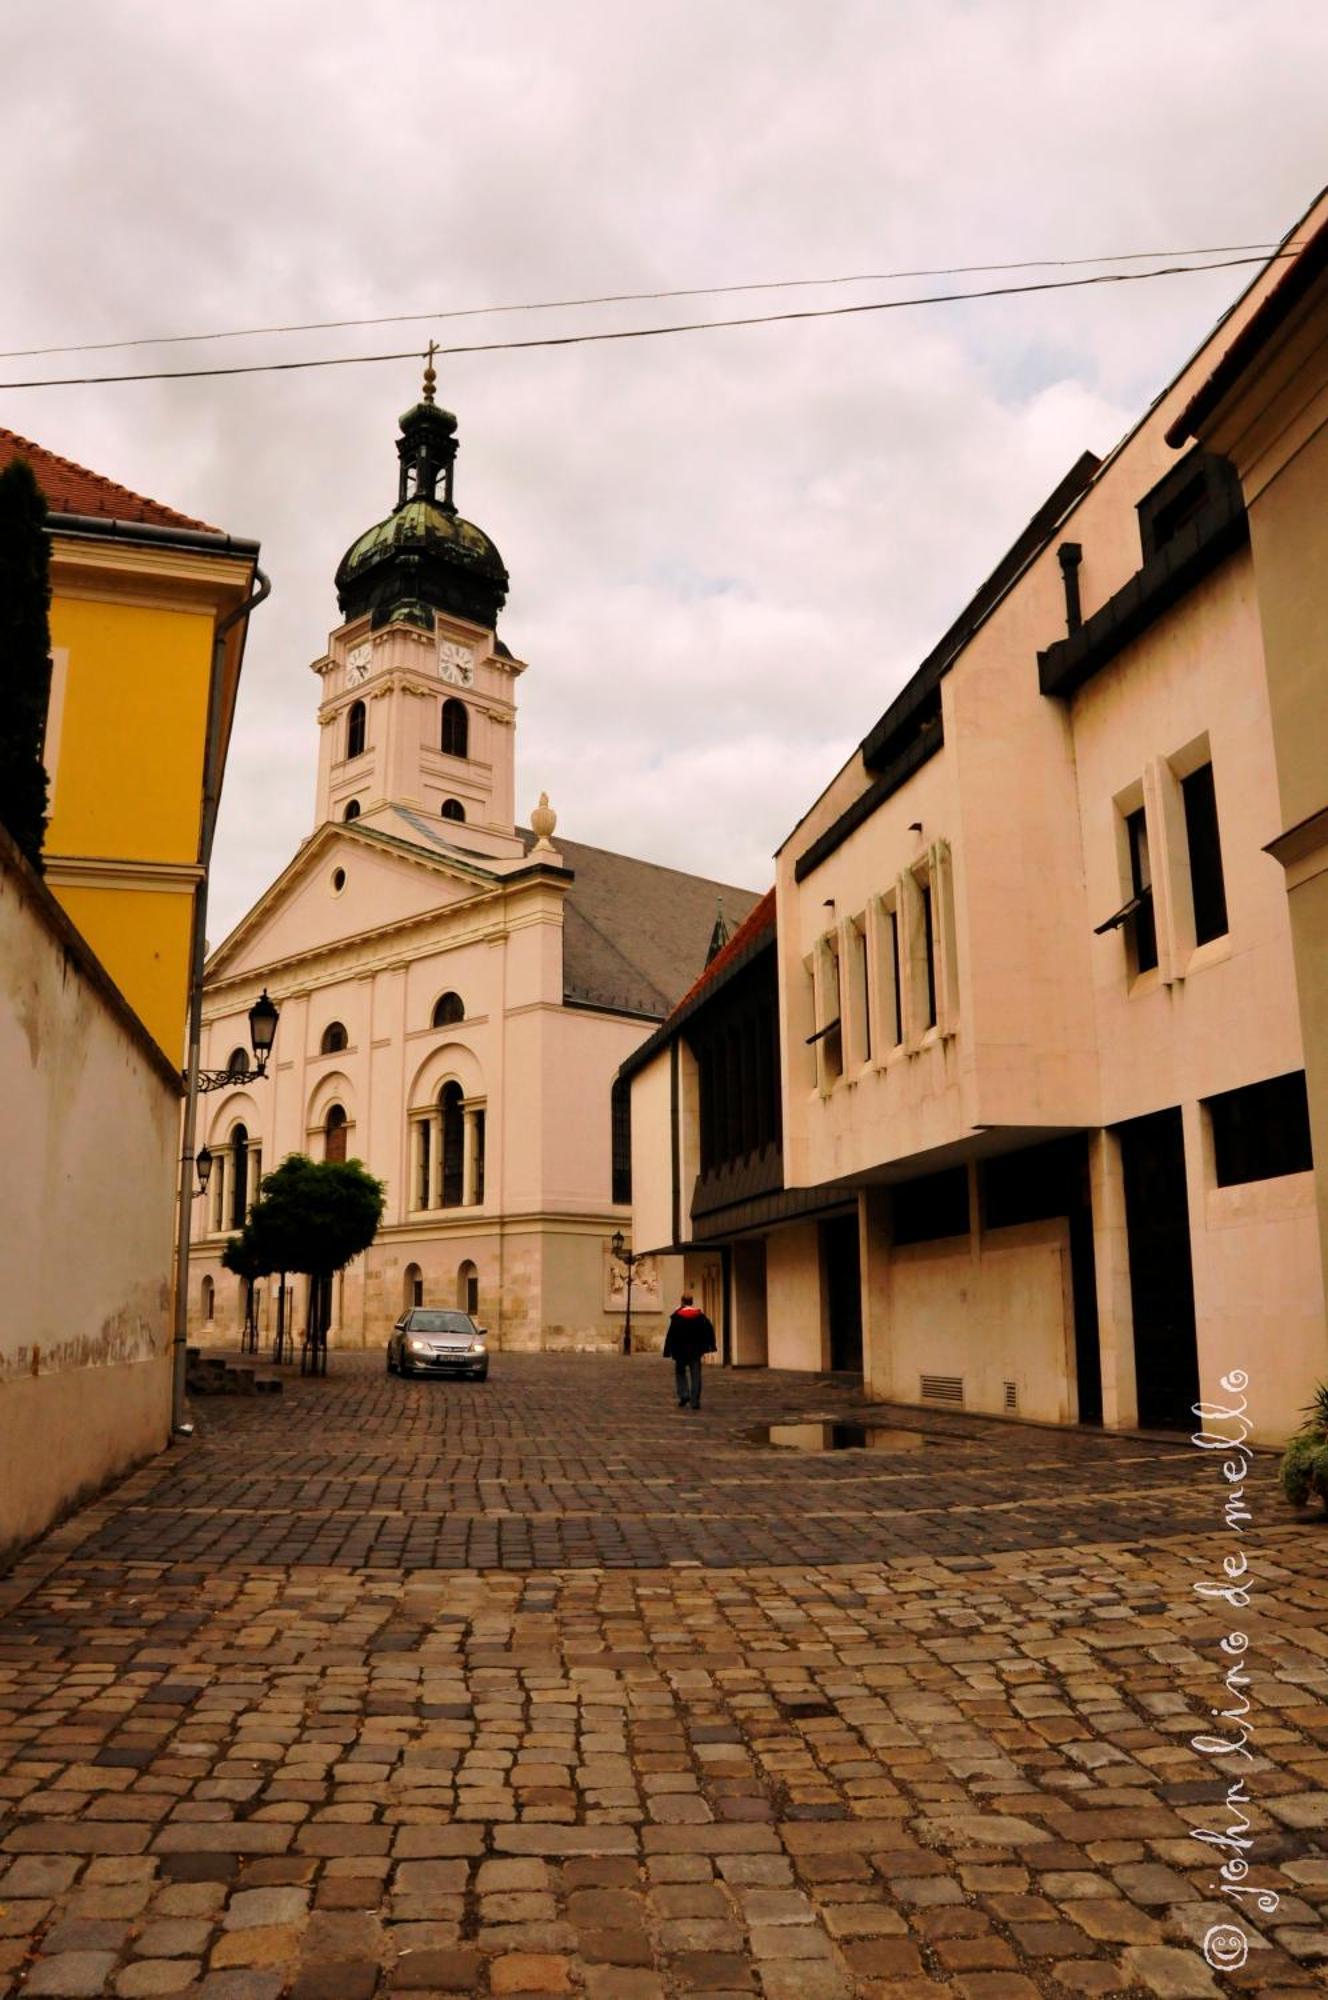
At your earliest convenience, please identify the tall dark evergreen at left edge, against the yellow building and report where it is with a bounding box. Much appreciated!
[0,458,50,870]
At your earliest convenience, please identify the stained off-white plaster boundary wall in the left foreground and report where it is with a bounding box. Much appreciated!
[0,840,180,1554]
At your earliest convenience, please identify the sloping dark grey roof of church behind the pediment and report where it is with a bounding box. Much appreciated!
[384,806,760,1020]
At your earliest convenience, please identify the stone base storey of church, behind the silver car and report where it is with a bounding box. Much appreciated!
[190,1214,682,1354]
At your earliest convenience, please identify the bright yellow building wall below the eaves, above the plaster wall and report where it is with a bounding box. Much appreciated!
[46,588,214,1062]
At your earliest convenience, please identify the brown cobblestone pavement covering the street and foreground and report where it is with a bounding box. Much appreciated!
[0,1356,1328,2000]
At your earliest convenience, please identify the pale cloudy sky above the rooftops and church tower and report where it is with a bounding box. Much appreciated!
[0,0,1328,942]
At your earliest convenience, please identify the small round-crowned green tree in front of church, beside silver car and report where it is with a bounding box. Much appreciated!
[246,1152,386,1368]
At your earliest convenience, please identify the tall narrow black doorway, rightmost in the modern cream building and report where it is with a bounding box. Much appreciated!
[1116,1110,1198,1430]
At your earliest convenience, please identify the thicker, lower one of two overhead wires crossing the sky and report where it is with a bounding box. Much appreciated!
[0,244,1294,390]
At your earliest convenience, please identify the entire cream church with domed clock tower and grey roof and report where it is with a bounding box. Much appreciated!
[190,370,756,1348]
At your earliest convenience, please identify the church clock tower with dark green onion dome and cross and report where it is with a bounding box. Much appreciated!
[314,356,524,860]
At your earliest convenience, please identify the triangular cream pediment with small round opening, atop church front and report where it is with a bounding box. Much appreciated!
[206,824,498,982]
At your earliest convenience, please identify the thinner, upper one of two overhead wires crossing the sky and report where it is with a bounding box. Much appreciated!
[0,242,1278,362]
